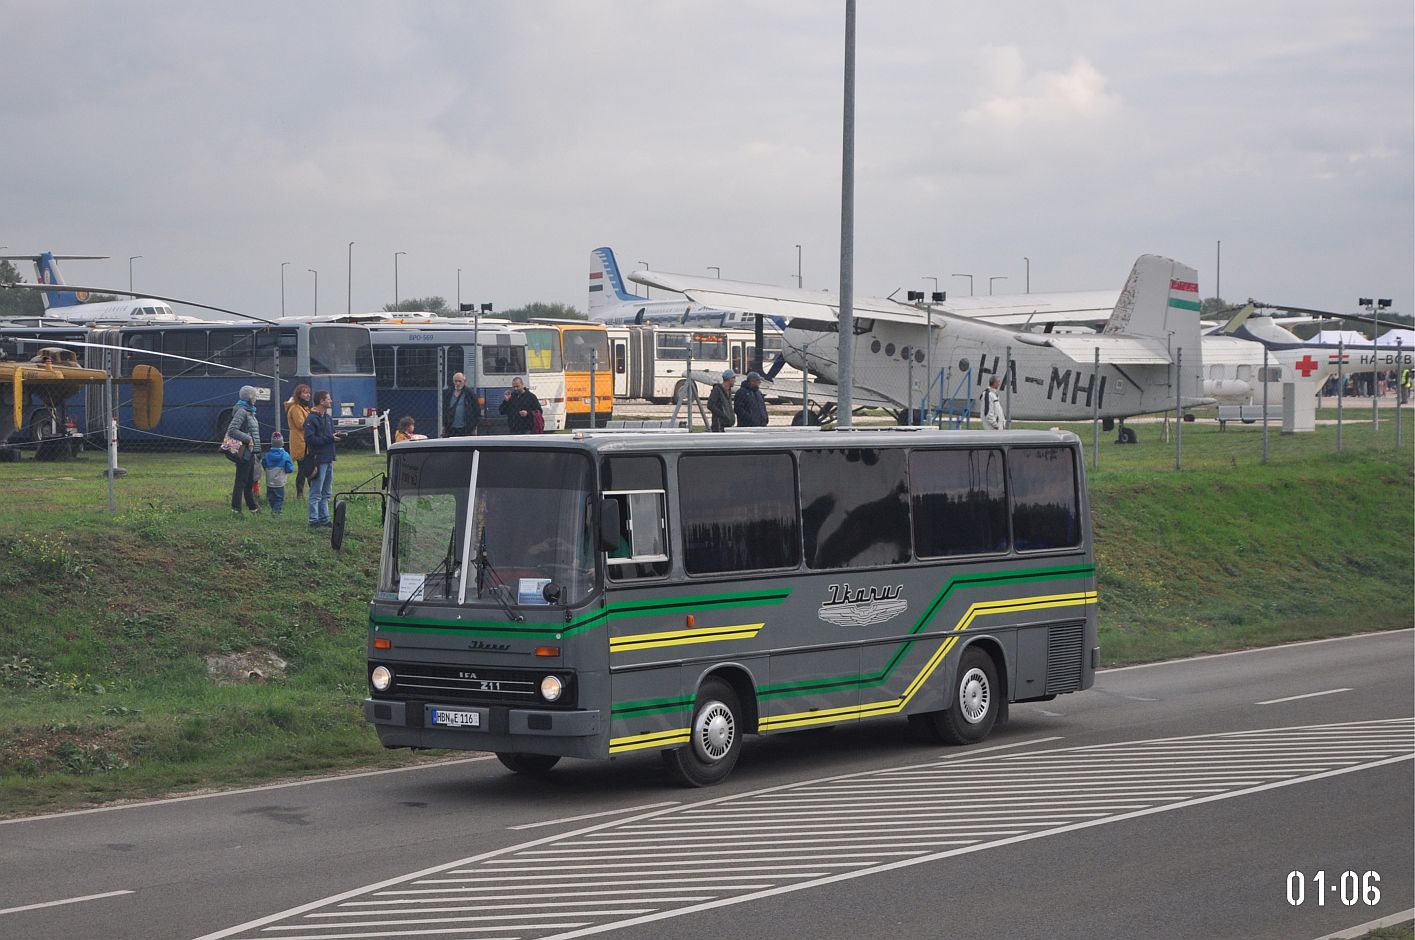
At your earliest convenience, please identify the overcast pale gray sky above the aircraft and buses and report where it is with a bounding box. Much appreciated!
[0,0,1415,316]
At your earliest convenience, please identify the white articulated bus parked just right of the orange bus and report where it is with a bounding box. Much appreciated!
[608,324,801,403]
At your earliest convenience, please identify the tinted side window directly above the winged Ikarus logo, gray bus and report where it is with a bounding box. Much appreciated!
[801,447,908,569]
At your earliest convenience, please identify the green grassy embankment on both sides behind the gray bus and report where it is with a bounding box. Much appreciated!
[0,419,1415,814]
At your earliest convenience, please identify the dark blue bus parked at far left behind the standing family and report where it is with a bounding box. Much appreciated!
[0,319,378,447]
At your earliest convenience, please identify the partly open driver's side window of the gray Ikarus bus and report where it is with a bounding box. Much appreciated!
[603,456,669,580]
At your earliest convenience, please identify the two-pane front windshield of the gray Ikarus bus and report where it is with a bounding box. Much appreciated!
[379,450,594,607]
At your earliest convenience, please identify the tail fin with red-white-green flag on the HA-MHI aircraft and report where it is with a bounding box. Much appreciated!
[1101,255,1203,389]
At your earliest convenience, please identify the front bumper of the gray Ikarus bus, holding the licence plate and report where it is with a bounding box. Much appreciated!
[364,698,604,757]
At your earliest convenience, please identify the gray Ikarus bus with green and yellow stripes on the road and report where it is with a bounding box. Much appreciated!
[364,428,1099,786]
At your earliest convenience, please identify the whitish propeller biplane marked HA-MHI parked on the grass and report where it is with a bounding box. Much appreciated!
[630,255,1213,440]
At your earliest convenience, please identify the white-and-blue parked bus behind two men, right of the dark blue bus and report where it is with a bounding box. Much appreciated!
[368,321,526,437]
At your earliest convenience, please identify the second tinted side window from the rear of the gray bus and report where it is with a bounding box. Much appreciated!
[908,447,1007,558]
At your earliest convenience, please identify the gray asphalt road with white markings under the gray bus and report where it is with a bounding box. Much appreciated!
[0,630,1415,940]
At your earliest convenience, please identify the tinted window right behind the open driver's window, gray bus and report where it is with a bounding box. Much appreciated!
[678,453,801,575]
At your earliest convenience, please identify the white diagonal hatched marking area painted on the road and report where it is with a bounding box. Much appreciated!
[201,718,1415,940]
